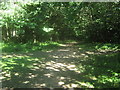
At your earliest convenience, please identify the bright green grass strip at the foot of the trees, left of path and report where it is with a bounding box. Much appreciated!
[2,42,59,53]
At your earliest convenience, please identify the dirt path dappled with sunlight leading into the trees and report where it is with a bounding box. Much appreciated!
[3,42,94,88]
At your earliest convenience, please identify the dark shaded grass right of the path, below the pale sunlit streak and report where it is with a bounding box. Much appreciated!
[77,47,120,88]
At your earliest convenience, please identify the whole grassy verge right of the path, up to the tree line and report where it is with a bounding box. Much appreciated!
[77,43,120,88]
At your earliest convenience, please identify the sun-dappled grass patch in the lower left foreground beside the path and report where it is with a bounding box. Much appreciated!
[2,56,43,88]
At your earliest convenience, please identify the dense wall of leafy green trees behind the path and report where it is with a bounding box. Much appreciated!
[1,2,120,43]
